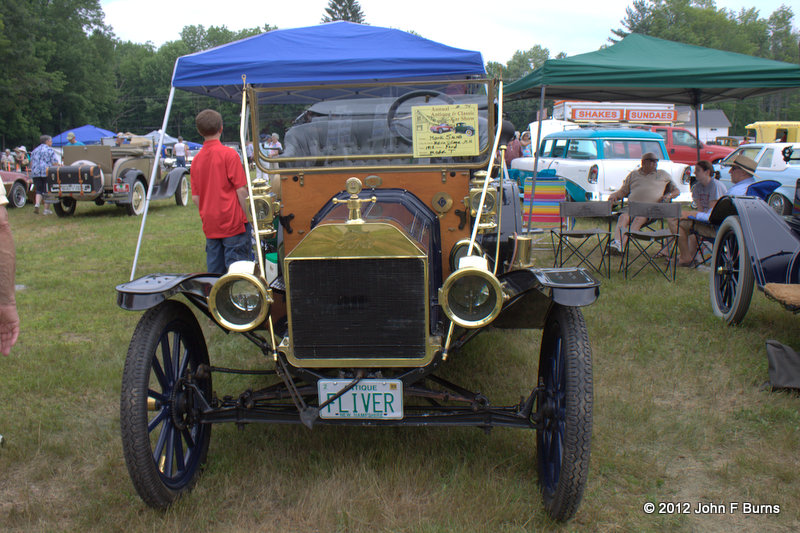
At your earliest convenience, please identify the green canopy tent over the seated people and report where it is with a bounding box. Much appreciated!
[504,33,800,169]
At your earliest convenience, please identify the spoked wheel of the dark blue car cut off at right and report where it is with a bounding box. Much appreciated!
[709,216,754,326]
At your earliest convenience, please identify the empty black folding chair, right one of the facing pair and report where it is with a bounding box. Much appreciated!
[620,202,681,281]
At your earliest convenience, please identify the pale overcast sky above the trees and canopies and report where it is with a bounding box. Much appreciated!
[100,0,800,64]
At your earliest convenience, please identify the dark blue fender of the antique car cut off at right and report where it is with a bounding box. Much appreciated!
[709,196,800,287]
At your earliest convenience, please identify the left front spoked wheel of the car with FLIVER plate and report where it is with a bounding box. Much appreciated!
[120,300,212,508]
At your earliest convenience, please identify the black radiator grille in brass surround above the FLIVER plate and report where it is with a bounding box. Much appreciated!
[288,258,427,359]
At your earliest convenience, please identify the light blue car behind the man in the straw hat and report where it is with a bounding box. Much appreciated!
[719,142,800,215]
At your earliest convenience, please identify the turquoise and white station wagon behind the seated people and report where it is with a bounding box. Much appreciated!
[511,128,691,202]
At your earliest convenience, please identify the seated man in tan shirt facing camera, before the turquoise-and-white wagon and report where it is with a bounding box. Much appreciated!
[608,152,680,253]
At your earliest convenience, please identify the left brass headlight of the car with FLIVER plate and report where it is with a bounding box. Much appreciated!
[208,261,272,331]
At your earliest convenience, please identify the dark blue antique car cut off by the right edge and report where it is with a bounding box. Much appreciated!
[709,146,800,325]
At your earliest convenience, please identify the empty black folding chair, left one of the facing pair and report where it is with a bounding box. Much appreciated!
[551,197,613,278]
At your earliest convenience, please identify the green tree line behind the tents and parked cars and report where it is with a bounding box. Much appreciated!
[0,0,800,148]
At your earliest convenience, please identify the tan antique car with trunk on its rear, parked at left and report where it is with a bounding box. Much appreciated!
[45,137,189,217]
